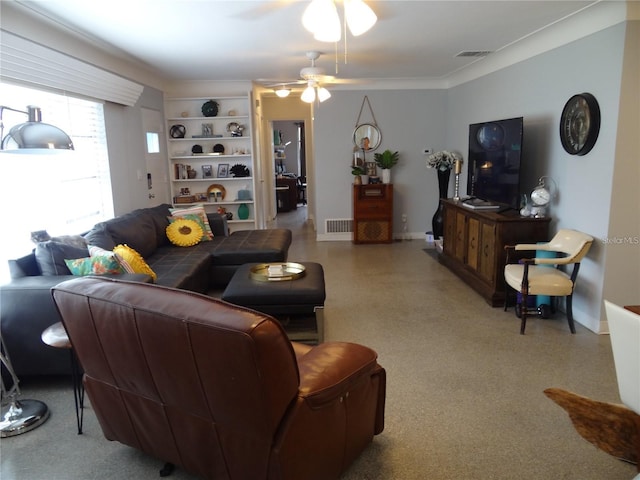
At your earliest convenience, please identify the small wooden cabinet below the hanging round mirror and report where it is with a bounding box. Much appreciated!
[353,183,393,243]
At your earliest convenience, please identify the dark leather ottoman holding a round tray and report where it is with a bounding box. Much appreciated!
[222,262,326,343]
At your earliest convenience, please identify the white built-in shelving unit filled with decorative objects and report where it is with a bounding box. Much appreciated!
[165,95,256,230]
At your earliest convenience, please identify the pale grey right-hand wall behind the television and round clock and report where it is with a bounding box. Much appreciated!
[447,24,625,331]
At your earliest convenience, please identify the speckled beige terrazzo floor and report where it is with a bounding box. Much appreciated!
[0,208,636,480]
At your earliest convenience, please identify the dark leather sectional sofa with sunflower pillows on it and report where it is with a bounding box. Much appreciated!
[0,204,291,376]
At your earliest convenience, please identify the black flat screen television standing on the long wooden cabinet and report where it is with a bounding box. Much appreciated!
[467,117,523,209]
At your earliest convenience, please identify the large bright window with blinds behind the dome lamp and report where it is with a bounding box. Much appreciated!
[0,83,113,281]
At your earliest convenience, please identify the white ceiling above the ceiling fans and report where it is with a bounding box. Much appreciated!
[16,0,598,86]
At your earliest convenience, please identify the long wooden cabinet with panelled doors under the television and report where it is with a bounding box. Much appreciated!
[439,199,551,307]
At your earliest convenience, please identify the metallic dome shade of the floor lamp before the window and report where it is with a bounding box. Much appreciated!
[0,105,73,153]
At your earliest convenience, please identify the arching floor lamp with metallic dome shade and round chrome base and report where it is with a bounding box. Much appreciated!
[0,105,73,437]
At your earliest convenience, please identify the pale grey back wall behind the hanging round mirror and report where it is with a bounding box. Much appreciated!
[314,90,444,240]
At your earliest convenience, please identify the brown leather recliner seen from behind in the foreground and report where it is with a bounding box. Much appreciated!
[52,277,386,480]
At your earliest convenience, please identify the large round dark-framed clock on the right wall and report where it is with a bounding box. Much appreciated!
[560,93,600,155]
